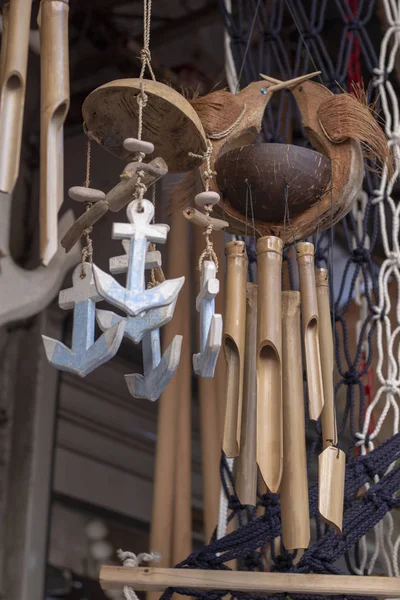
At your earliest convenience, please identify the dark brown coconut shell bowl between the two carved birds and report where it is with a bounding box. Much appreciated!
[215,144,331,222]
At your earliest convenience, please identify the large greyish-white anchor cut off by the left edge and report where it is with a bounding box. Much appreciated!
[0,194,80,325]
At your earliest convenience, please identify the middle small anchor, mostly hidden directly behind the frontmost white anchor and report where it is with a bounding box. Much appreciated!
[96,240,178,344]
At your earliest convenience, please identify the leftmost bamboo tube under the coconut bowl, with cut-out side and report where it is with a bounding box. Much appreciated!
[222,241,248,458]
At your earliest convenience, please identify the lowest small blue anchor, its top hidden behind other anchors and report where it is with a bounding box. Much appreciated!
[125,329,182,402]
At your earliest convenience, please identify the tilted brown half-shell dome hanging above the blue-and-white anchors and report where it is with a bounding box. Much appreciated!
[82,79,207,173]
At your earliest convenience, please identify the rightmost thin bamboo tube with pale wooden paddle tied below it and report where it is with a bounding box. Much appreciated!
[316,269,346,533]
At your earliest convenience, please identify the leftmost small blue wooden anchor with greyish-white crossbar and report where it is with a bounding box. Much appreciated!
[42,263,125,377]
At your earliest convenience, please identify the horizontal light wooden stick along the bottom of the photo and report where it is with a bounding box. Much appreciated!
[100,566,400,598]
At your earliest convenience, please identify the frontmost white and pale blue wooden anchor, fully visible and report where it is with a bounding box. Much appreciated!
[93,200,185,316]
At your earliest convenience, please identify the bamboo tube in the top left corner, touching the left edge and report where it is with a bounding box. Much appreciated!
[0,0,32,194]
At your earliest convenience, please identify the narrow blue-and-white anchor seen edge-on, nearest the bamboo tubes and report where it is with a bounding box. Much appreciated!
[193,260,222,379]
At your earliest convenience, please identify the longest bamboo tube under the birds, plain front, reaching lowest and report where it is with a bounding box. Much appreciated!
[280,292,310,550]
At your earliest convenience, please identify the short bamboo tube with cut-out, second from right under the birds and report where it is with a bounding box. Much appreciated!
[297,242,324,421]
